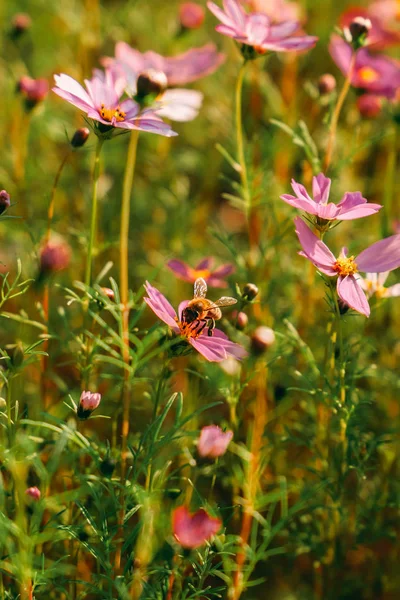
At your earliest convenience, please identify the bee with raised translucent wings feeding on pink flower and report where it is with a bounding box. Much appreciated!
[182,277,237,336]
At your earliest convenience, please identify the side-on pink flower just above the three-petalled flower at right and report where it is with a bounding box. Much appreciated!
[281,173,382,221]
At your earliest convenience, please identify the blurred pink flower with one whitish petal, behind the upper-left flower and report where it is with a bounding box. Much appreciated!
[103,42,225,122]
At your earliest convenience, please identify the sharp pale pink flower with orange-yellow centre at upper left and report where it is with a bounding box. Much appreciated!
[53,70,177,137]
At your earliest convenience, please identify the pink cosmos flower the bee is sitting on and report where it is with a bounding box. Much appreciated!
[144,282,247,362]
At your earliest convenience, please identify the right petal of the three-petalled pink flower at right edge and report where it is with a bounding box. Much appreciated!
[356,234,400,273]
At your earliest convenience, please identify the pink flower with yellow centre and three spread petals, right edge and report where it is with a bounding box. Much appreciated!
[294,217,400,317]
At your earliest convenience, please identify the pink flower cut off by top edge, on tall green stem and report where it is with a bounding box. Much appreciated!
[207,0,318,54]
